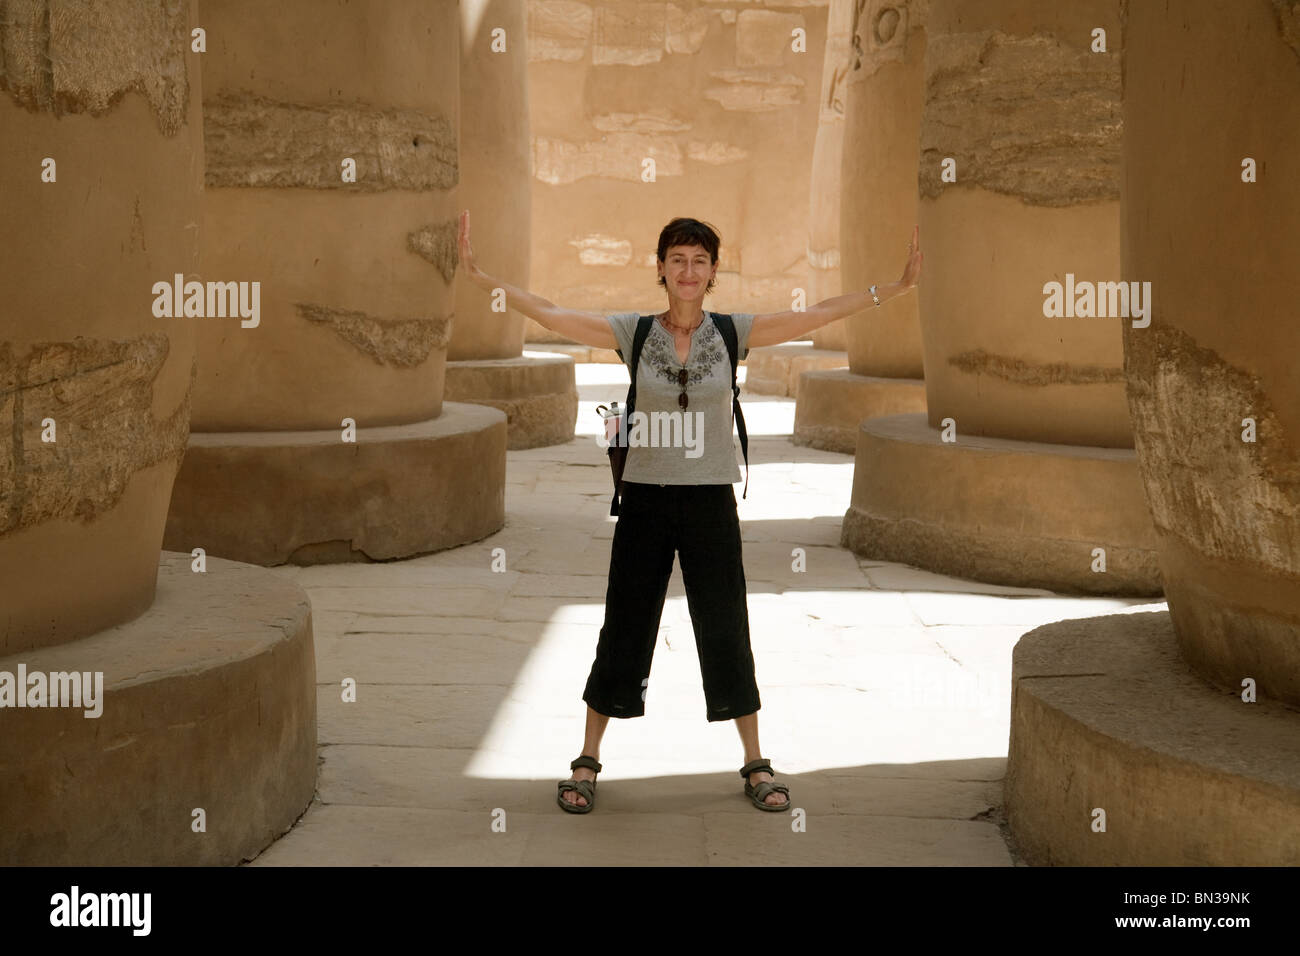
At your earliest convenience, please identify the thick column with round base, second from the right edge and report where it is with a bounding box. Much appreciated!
[842,0,1160,594]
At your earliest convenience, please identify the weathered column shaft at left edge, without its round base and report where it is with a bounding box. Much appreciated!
[0,0,203,653]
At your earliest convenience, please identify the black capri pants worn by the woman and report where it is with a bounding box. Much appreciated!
[582,481,761,721]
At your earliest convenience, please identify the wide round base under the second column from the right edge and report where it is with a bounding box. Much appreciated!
[840,415,1161,594]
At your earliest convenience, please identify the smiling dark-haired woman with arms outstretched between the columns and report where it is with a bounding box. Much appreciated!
[460,211,922,813]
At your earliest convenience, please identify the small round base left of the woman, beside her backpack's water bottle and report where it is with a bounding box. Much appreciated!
[442,352,577,450]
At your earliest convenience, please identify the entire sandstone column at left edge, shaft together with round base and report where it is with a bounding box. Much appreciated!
[0,0,316,866]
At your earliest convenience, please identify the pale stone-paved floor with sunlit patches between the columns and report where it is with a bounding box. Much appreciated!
[255,364,1164,866]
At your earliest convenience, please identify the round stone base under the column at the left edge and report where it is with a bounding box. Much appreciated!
[0,551,316,866]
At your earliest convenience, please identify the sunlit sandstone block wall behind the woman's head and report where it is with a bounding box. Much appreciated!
[528,0,827,341]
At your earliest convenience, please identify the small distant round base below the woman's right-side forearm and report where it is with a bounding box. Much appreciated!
[793,368,926,455]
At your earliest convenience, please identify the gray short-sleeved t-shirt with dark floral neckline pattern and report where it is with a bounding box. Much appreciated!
[606,311,754,485]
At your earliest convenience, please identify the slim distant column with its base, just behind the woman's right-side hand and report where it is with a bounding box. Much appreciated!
[793,0,927,455]
